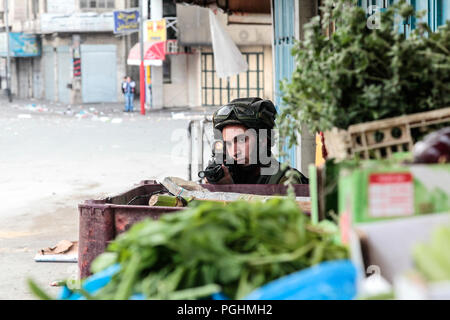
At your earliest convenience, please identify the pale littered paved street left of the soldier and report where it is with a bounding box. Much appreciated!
[0,100,214,299]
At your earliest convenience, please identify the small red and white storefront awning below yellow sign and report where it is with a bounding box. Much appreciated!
[127,41,166,66]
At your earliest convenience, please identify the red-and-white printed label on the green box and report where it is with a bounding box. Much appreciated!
[369,173,414,218]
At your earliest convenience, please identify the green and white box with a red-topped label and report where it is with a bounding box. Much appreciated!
[338,161,450,223]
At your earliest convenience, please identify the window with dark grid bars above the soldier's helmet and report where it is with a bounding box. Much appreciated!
[201,52,264,106]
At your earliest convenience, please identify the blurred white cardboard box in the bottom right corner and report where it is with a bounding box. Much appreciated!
[349,212,450,300]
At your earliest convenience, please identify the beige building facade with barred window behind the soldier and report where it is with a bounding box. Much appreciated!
[170,4,273,107]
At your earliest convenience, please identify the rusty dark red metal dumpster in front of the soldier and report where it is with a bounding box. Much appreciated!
[78,180,309,278]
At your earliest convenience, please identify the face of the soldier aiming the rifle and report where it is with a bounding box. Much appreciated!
[222,124,257,165]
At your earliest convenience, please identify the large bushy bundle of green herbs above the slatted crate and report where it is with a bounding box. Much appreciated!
[279,0,450,143]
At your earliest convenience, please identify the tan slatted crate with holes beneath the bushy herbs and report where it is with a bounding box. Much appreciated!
[324,108,450,160]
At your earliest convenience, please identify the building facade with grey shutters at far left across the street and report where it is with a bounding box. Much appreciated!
[0,0,138,104]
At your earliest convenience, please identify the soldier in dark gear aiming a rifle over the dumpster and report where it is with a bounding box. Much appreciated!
[199,98,308,184]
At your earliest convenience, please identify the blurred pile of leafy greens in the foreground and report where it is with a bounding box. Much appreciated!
[86,198,348,300]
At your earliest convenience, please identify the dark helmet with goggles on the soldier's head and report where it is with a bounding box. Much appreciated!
[213,98,277,130]
